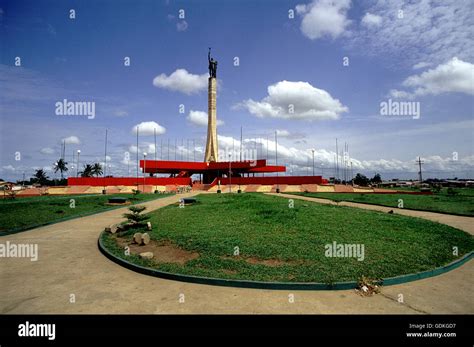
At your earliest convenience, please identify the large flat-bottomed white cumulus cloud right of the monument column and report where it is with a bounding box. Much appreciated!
[235,81,348,120]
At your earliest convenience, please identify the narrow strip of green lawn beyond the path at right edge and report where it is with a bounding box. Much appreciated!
[296,188,474,216]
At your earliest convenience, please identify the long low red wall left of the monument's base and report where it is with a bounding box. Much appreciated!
[67,177,192,186]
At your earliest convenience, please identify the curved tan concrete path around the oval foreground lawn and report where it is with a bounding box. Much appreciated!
[0,193,474,314]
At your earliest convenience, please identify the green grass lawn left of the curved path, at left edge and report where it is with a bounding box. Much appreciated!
[0,194,170,235]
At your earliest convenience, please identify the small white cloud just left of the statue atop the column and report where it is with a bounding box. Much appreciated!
[153,69,208,95]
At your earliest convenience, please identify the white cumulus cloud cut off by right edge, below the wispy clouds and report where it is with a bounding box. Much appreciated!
[392,58,474,97]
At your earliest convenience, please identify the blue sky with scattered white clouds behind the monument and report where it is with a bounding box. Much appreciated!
[0,0,474,179]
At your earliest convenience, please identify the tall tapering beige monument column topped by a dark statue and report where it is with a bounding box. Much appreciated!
[204,48,219,162]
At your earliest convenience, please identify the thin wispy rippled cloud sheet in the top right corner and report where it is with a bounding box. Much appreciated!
[351,0,474,65]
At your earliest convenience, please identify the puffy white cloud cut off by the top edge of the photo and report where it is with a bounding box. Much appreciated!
[296,0,351,40]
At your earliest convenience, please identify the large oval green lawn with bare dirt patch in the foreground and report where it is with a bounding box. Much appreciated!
[102,193,474,283]
